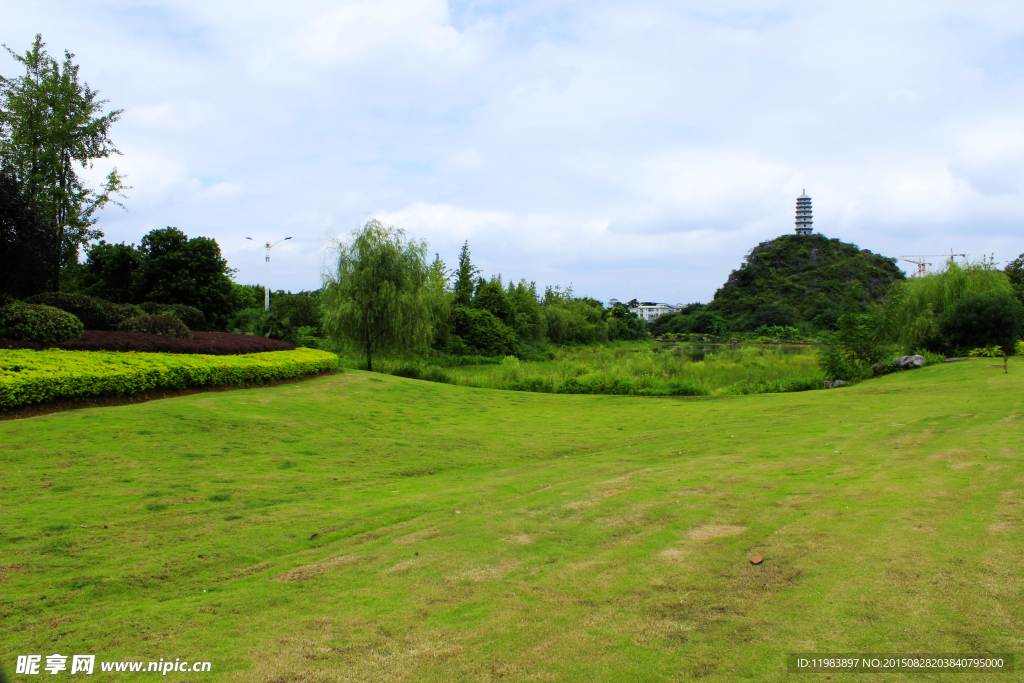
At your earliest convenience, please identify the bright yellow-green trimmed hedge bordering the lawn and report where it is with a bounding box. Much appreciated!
[0,348,338,409]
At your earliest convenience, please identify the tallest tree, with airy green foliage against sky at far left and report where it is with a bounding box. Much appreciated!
[0,35,129,290]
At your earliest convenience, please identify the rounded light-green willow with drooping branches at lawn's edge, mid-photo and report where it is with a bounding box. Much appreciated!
[321,220,444,371]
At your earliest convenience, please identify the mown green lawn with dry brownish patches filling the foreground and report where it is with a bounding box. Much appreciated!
[0,358,1024,681]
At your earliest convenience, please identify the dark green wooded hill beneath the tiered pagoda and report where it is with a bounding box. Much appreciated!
[703,234,905,330]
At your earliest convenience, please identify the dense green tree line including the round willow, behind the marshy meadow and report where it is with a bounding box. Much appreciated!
[322,220,647,368]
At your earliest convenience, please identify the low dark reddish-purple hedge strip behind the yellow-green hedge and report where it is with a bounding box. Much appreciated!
[0,330,295,355]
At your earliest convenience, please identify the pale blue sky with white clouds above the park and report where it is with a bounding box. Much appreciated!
[0,0,1024,303]
